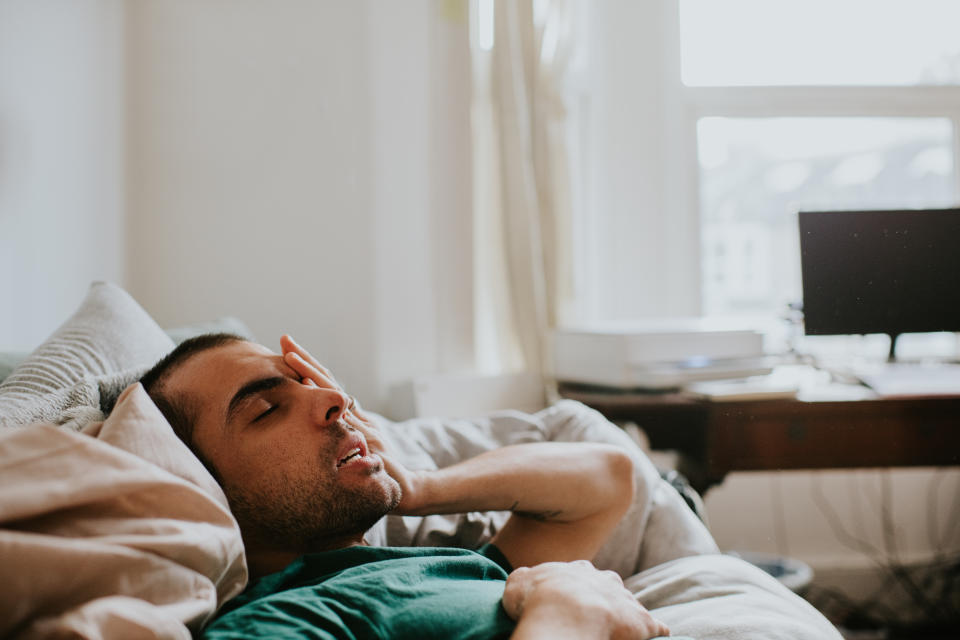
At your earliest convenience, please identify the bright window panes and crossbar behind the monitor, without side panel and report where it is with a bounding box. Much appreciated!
[679,0,960,315]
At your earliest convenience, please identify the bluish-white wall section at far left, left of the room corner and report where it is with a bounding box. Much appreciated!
[0,0,124,351]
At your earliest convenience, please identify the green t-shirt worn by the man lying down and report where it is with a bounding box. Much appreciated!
[203,545,514,640]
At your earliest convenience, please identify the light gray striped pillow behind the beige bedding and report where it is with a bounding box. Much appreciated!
[0,282,174,428]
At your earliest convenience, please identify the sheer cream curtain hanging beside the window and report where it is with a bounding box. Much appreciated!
[474,0,573,380]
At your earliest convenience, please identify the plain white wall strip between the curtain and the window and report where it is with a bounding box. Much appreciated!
[585,0,700,320]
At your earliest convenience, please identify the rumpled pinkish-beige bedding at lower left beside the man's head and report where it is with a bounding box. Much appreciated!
[0,385,247,639]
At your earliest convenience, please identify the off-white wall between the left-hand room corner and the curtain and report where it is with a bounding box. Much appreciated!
[127,0,472,410]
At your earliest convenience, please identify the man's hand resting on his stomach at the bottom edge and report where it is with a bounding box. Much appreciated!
[503,560,670,640]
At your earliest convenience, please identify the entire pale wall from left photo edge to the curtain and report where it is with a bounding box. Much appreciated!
[0,0,473,410]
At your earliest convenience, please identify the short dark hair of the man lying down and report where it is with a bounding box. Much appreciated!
[140,333,248,477]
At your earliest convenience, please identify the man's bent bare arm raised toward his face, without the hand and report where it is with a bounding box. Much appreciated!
[386,443,633,567]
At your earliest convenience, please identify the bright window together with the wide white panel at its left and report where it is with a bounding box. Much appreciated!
[581,0,960,322]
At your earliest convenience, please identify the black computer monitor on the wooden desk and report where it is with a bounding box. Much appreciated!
[799,209,960,360]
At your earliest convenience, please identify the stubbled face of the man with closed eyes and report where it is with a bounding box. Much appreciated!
[164,342,400,553]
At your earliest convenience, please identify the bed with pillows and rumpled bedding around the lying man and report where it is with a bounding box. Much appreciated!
[0,282,840,640]
